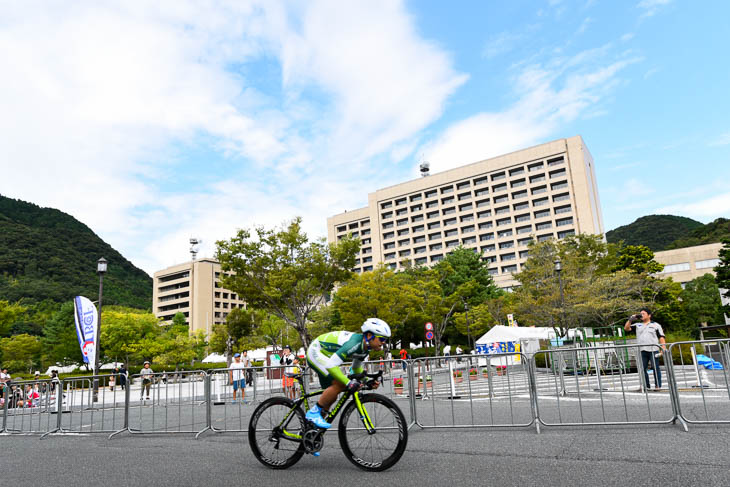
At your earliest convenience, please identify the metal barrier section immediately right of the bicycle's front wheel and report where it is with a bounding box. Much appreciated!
[411,353,535,428]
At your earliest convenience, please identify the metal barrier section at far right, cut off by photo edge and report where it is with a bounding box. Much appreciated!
[668,339,730,424]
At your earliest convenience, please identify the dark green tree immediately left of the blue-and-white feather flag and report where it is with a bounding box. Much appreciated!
[43,302,83,365]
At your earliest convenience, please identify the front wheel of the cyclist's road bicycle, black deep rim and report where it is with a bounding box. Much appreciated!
[338,394,408,472]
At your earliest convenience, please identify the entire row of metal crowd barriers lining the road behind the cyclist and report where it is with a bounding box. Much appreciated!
[0,339,730,438]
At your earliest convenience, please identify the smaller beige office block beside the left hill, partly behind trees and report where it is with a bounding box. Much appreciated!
[152,259,245,336]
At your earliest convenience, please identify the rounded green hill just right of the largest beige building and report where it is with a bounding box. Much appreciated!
[606,215,704,252]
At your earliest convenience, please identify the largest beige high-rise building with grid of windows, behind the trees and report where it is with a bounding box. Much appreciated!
[327,136,603,288]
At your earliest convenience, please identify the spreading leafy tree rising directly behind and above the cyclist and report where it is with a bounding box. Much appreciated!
[216,218,360,347]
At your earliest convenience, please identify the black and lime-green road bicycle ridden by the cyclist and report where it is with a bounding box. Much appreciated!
[248,369,408,472]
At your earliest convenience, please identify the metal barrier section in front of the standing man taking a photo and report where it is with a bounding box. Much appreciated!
[532,343,677,426]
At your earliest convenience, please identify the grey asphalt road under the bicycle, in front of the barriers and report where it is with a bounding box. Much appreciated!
[0,425,730,487]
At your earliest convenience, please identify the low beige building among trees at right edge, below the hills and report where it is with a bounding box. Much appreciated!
[654,243,722,286]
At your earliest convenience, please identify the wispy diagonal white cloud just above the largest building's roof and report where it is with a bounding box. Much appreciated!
[422,44,638,172]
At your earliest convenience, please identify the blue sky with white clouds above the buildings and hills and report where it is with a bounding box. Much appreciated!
[0,0,730,273]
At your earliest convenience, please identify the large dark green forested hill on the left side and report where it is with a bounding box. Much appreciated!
[0,195,152,309]
